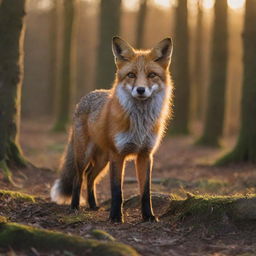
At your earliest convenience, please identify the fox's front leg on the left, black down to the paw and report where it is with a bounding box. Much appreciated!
[109,157,124,222]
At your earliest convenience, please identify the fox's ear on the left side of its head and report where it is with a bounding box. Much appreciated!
[112,36,135,63]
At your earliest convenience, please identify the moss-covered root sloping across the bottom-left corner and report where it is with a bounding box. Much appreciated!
[0,222,138,256]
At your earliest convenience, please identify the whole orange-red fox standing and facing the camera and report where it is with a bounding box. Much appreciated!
[51,36,173,222]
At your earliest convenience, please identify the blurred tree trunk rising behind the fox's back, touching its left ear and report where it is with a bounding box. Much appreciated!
[95,0,121,88]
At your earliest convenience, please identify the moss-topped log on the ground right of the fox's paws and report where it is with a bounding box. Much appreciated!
[162,194,256,223]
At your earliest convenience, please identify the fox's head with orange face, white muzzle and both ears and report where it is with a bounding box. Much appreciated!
[112,37,172,100]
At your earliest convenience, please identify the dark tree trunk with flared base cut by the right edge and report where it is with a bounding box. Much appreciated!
[217,0,256,164]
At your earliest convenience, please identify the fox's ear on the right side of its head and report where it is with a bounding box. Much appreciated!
[150,38,173,68]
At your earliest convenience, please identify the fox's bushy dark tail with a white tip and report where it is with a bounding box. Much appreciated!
[51,132,76,204]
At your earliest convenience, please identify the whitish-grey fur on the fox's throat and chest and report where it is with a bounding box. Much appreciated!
[114,86,165,153]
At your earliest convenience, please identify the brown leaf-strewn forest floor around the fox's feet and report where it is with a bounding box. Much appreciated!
[0,119,256,256]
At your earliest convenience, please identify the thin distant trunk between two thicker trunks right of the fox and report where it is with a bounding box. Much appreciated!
[193,0,203,121]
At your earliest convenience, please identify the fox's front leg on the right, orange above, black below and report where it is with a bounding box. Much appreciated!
[136,153,158,221]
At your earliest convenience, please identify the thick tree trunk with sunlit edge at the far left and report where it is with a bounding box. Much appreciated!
[0,0,26,179]
